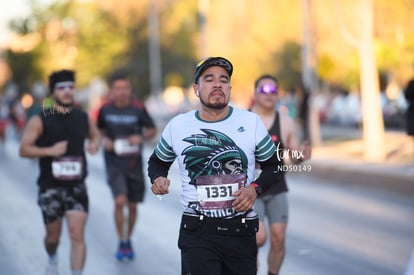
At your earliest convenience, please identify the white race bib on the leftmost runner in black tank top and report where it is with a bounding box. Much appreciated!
[52,157,83,180]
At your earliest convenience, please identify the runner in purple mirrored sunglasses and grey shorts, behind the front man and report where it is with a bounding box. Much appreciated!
[251,75,311,275]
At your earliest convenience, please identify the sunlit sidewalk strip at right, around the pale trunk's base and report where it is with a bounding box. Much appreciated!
[308,127,414,197]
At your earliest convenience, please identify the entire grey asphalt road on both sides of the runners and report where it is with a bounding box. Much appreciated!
[0,142,414,275]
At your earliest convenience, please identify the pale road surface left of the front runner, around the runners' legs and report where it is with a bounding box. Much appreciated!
[0,140,180,275]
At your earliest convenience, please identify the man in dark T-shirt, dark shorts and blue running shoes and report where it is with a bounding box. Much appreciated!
[98,74,156,260]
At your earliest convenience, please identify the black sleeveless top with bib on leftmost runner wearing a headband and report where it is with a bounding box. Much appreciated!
[36,108,89,188]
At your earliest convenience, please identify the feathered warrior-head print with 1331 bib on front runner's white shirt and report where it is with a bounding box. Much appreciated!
[182,129,248,217]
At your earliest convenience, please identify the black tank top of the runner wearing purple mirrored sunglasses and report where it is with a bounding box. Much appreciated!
[262,113,288,195]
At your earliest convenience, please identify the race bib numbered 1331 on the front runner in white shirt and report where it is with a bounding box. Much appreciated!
[196,174,246,210]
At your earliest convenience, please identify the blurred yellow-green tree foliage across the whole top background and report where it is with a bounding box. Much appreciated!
[6,0,414,103]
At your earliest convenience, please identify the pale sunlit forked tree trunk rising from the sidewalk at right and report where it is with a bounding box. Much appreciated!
[337,0,385,161]
